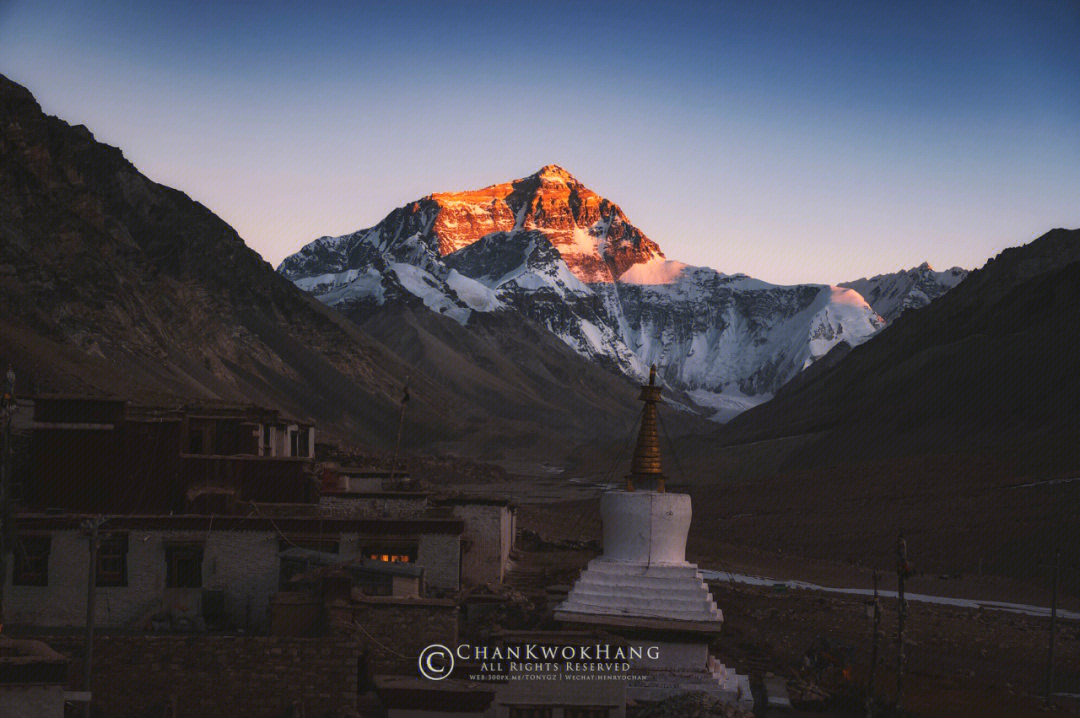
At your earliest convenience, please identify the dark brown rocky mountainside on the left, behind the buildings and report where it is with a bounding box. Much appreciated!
[0,71,453,442]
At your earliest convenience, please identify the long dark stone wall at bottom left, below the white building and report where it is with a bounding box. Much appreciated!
[23,636,360,718]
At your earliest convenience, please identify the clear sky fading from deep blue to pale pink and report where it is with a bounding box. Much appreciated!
[0,0,1080,283]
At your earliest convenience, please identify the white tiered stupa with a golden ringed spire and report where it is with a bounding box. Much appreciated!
[555,367,754,706]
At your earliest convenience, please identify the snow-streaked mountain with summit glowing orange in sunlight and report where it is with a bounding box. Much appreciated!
[279,165,885,418]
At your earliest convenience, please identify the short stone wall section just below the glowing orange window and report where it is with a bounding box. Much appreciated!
[327,596,458,676]
